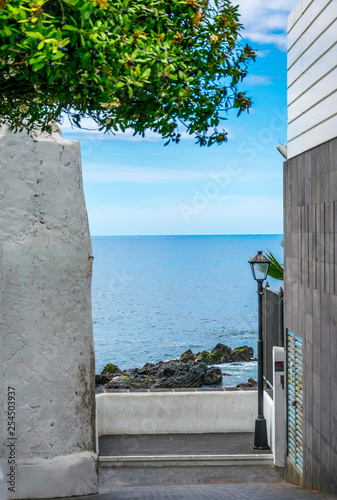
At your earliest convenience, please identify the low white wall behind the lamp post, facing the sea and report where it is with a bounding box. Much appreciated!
[96,391,262,436]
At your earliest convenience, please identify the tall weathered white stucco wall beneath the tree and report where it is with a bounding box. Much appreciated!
[0,126,97,499]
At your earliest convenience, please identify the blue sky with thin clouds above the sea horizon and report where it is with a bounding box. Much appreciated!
[62,0,297,235]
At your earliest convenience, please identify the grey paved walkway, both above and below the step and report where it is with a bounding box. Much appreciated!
[48,433,337,500]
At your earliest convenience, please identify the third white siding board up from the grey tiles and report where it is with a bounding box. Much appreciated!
[288,69,337,123]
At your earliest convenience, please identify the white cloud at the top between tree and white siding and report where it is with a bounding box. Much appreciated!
[239,0,298,50]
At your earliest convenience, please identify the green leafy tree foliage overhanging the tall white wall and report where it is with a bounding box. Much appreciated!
[0,0,255,145]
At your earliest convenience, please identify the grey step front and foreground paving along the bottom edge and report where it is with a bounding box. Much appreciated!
[51,466,337,500]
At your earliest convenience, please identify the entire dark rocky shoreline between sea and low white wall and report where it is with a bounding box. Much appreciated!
[95,344,255,389]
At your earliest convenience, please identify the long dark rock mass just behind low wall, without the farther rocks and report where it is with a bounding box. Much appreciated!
[101,361,222,389]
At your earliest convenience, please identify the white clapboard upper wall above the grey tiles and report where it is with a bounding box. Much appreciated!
[288,0,337,158]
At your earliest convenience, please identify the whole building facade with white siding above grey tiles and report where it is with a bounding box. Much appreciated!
[284,0,337,494]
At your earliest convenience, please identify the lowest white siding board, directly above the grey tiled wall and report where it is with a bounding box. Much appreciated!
[288,112,337,159]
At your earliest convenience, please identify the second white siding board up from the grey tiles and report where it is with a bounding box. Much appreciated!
[288,93,337,142]
